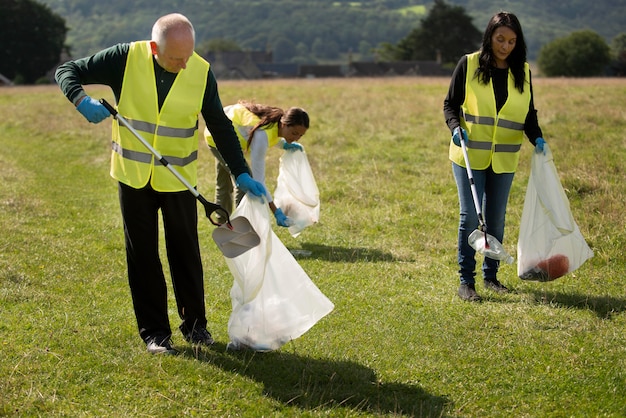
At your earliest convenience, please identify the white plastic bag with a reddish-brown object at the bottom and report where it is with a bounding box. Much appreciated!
[517,144,593,282]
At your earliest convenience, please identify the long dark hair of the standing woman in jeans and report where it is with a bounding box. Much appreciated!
[475,12,526,92]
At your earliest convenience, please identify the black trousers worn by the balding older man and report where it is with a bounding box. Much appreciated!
[119,183,207,340]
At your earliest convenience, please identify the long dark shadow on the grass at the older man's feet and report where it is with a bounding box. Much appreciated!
[187,343,450,417]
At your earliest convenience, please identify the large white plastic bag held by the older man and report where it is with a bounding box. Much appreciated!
[225,195,334,351]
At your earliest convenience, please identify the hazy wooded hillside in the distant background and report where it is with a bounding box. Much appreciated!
[39,0,626,63]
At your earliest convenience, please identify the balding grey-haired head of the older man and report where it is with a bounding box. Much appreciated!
[150,13,195,73]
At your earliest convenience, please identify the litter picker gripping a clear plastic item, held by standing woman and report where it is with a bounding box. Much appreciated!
[458,126,514,264]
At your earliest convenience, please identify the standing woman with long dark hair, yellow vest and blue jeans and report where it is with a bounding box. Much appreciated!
[443,12,545,301]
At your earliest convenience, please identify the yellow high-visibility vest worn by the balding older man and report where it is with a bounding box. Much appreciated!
[111,41,209,192]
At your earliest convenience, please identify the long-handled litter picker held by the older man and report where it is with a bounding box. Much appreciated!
[100,99,261,258]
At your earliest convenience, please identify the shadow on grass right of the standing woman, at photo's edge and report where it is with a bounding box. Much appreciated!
[533,291,626,319]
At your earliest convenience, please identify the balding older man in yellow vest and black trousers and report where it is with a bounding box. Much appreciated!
[55,13,266,354]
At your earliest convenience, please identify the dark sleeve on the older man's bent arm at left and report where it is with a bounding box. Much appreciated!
[54,44,130,104]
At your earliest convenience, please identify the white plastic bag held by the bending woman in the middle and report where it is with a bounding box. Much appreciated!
[274,150,320,238]
